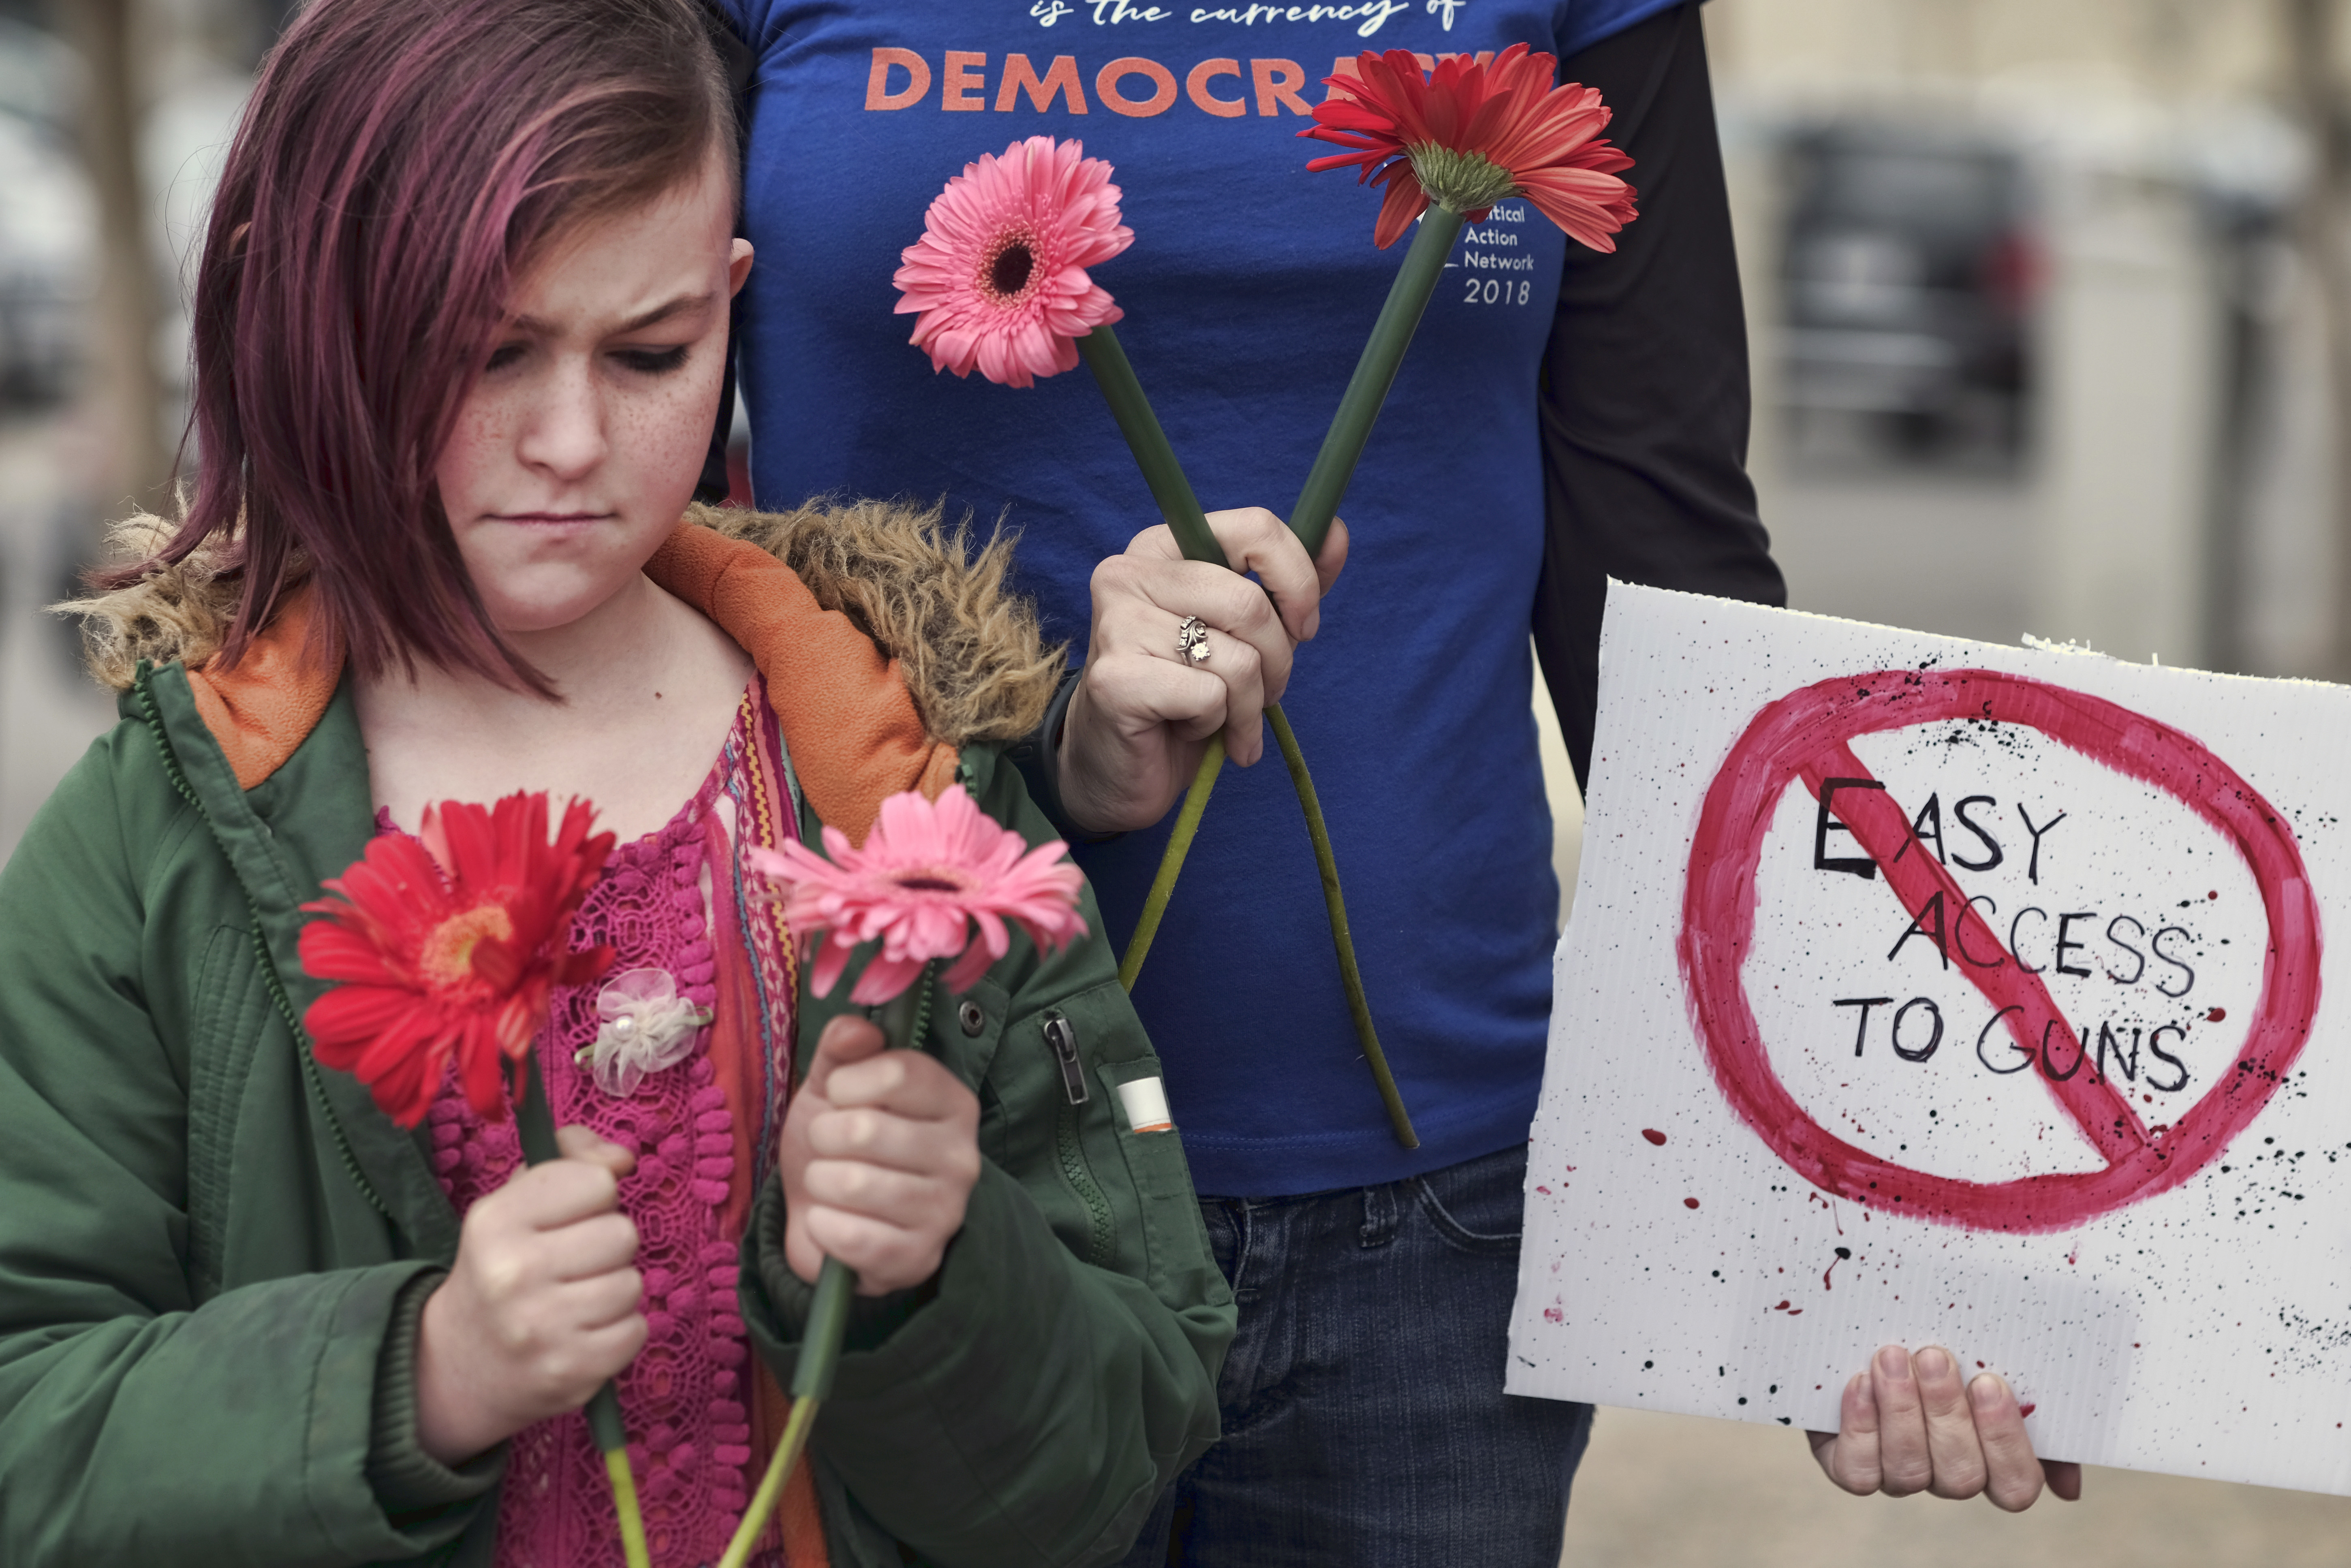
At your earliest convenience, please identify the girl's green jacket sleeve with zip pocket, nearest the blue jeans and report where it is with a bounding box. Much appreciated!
[743,748,1234,1568]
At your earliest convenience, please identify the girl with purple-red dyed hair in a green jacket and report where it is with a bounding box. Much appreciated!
[0,0,1232,1568]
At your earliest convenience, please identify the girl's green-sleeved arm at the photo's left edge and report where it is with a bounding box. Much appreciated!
[0,726,501,1568]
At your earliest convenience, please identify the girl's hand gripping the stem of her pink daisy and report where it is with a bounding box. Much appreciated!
[778,1016,980,1295]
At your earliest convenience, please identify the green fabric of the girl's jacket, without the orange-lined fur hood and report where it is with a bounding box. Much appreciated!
[0,510,1234,1568]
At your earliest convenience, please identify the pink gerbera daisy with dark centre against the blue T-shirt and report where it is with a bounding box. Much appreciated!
[891,137,1135,386]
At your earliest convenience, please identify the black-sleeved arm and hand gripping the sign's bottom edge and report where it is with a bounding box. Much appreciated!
[1535,0,2081,1509]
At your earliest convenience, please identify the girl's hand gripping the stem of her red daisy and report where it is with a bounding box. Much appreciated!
[416,1126,644,1465]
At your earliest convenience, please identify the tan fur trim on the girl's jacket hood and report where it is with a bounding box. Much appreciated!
[56,501,1063,748]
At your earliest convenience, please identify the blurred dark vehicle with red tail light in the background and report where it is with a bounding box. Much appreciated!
[1782,120,2036,456]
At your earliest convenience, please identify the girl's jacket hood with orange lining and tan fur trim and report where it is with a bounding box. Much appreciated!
[59,501,1063,842]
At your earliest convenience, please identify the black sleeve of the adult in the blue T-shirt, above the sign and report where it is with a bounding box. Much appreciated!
[1535,2,1787,783]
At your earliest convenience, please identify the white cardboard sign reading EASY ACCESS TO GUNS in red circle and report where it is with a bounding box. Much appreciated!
[1509,583,2351,1493]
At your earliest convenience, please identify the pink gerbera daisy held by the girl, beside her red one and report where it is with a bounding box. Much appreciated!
[750,785,1086,1006]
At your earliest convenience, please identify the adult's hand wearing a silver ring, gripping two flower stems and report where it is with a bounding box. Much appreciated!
[1058,508,1347,832]
